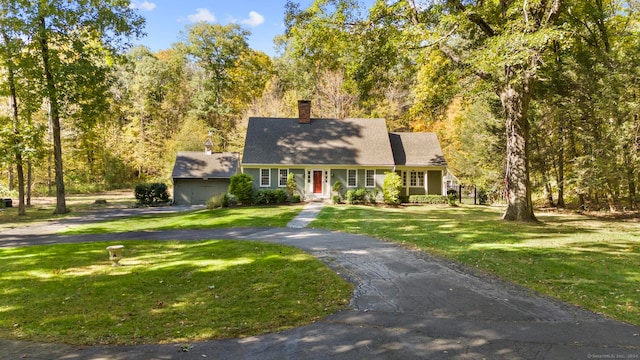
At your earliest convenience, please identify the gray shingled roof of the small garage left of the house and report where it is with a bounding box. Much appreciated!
[171,151,239,179]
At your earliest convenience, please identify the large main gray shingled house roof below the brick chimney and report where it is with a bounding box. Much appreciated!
[242,118,394,166]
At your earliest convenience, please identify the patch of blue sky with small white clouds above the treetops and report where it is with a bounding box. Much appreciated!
[126,0,320,56]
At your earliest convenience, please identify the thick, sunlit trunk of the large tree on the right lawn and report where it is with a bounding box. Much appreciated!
[500,66,536,221]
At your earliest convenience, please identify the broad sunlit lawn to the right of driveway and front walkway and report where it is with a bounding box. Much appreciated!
[311,206,640,325]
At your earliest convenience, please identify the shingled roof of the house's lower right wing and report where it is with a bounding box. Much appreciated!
[389,133,447,166]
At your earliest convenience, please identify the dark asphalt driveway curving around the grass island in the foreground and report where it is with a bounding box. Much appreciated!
[0,207,640,359]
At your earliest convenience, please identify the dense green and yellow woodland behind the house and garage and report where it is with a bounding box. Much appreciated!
[0,0,640,220]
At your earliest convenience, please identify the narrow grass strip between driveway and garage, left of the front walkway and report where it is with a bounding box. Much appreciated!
[63,205,303,235]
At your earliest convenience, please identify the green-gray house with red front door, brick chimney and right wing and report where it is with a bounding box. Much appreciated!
[242,101,447,200]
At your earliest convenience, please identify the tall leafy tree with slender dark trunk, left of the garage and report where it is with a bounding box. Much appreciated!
[13,0,144,214]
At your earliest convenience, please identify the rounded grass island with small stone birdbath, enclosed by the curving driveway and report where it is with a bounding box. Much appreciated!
[0,240,352,345]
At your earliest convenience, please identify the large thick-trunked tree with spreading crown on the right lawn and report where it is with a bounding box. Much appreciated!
[352,0,563,221]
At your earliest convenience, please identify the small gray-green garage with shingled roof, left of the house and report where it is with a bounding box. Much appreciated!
[172,151,239,205]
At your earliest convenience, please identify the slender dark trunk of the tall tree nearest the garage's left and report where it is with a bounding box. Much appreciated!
[38,16,67,214]
